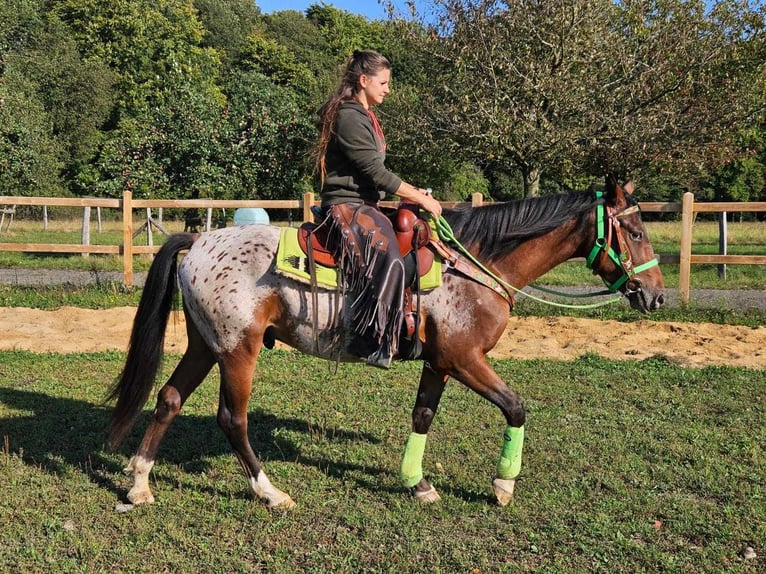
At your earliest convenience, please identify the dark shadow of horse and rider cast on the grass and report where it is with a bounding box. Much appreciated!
[0,388,414,504]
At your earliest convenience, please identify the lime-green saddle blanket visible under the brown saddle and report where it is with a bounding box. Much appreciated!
[277,227,442,291]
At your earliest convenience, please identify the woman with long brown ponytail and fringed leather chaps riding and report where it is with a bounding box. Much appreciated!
[317,50,441,368]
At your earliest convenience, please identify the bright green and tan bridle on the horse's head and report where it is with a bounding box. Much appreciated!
[586,191,659,293]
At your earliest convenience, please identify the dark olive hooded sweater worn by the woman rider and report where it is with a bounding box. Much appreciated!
[322,100,402,207]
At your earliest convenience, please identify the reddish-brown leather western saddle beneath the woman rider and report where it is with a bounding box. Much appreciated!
[298,202,434,285]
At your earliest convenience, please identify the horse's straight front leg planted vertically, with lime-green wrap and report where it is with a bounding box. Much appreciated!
[400,363,447,502]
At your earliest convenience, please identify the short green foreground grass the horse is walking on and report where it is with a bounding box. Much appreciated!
[0,352,766,573]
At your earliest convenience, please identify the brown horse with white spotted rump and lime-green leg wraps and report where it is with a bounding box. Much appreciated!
[108,182,665,508]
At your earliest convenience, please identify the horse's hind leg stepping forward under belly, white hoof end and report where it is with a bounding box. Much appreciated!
[218,336,295,509]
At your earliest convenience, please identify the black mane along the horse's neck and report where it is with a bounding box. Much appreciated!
[443,191,603,263]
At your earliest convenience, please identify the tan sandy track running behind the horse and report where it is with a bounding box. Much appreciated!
[0,307,766,369]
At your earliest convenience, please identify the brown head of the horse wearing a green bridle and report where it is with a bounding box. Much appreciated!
[587,179,665,313]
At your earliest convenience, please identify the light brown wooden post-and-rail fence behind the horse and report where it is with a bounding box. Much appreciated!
[0,192,766,304]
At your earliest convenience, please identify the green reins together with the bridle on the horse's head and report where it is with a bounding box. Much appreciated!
[436,197,659,316]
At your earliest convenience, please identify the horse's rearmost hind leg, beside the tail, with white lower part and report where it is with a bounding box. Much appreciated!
[125,327,215,504]
